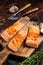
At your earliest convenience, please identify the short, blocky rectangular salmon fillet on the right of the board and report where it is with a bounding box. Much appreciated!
[26,25,40,48]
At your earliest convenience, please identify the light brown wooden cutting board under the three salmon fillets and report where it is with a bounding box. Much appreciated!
[0,21,43,65]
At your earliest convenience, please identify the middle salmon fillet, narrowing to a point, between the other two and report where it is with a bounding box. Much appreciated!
[8,23,29,52]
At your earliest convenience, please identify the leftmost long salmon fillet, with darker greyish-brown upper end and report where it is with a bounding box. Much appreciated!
[1,16,29,42]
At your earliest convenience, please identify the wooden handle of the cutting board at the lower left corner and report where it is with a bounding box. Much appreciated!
[0,48,10,65]
